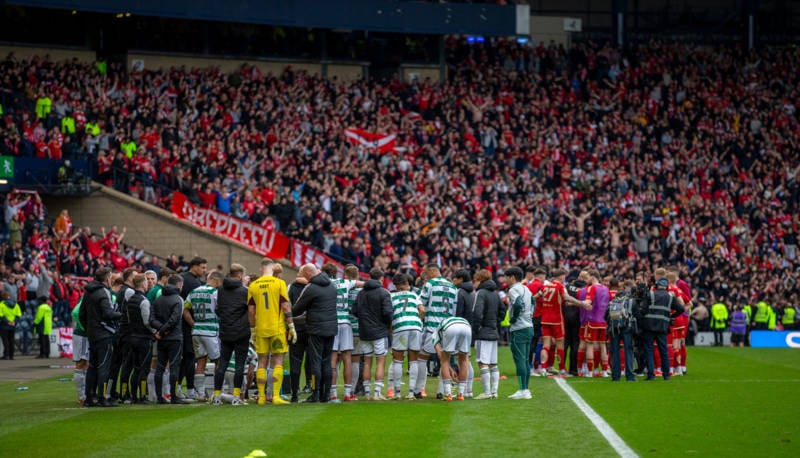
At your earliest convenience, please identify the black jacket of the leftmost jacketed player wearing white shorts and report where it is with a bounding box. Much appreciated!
[350,279,392,340]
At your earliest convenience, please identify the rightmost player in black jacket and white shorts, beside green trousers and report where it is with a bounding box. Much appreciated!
[472,269,506,399]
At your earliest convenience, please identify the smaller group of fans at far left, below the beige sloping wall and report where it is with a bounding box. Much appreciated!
[0,190,206,355]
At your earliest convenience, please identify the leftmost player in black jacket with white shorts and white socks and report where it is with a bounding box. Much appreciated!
[350,267,392,400]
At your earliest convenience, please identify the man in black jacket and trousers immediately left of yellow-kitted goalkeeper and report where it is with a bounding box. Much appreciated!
[211,264,250,405]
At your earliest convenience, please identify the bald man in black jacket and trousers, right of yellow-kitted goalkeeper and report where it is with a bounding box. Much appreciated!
[292,264,338,402]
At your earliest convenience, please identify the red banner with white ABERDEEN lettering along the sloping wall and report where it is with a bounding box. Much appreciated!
[172,192,289,259]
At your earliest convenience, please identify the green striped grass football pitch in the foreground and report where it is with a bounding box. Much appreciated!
[0,347,800,457]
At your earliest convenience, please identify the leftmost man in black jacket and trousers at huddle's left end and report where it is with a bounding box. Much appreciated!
[79,267,122,407]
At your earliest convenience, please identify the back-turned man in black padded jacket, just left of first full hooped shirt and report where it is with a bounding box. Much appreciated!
[150,275,187,404]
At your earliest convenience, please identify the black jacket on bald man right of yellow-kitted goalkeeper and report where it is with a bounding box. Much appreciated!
[292,273,339,337]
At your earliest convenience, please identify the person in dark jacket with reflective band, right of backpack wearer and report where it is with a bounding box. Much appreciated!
[639,268,684,381]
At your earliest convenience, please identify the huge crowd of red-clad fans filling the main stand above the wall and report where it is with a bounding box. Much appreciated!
[0,37,800,318]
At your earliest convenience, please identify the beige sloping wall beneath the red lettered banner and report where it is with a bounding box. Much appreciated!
[44,185,297,282]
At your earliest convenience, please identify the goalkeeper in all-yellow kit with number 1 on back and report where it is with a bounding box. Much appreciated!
[247,258,297,405]
